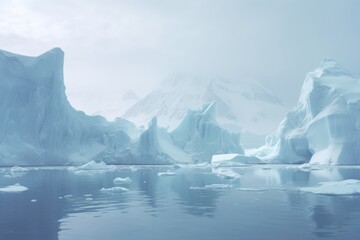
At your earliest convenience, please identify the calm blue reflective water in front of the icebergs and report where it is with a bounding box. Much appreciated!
[0,166,360,240]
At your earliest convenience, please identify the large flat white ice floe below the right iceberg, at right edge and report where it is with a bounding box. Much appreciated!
[299,179,360,195]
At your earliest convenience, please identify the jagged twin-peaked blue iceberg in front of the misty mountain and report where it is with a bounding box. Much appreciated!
[101,103,244,164]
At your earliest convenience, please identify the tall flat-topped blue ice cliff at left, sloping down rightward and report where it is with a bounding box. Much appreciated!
[0,48,130,165]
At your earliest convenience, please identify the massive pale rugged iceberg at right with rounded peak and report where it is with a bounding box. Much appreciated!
[248,60,360,164]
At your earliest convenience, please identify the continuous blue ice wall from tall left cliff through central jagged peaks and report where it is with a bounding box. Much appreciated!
[0,48,243,166]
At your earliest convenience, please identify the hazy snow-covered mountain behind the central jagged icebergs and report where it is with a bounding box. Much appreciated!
[122,76,286,134]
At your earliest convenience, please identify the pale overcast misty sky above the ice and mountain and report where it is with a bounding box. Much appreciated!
[0,0,360,112]
